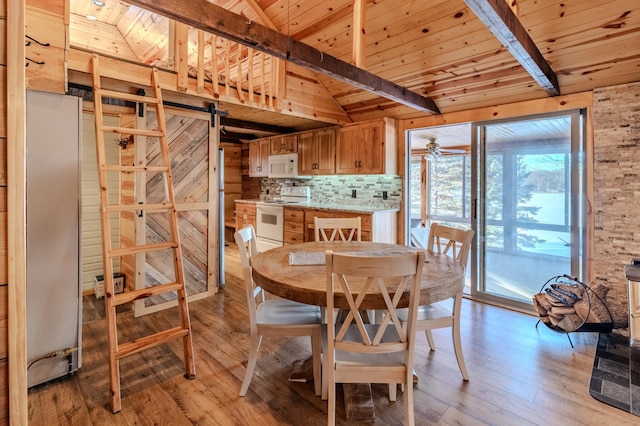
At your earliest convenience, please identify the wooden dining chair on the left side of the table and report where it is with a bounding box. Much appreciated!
[235,225,322,396]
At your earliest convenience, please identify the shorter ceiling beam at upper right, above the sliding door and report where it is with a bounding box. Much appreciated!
[464,0,560,96]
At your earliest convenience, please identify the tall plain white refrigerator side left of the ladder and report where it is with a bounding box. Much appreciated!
[26,91,82,387]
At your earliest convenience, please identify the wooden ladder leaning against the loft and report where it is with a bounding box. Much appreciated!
[92,55,196,413]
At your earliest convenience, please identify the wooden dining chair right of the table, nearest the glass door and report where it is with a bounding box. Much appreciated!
[398,223,475,380]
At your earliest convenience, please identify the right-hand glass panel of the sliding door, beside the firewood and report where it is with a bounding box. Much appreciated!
[471,112,584,309]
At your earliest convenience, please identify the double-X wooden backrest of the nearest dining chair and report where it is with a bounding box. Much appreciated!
[326,250,424,356]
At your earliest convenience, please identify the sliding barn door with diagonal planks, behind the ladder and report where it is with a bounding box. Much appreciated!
[135,108,218,316]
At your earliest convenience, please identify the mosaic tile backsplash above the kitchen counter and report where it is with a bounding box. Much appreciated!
[261,175,402,208]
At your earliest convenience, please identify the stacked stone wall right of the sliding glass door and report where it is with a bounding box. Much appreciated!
[593,82,640,328]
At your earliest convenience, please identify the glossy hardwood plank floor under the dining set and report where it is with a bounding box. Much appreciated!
[29,245,640,426]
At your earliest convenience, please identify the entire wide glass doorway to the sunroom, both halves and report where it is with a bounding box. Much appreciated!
[407,111,586,311]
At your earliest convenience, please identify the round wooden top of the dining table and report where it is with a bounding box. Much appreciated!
[252,241,465,309]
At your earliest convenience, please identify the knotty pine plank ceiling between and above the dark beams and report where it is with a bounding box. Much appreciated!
[70,0,640,129]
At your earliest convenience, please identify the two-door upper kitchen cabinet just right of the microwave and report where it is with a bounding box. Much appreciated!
[298,127,336,176]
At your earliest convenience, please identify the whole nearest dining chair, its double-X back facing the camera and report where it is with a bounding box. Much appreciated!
[322,250,424,425]
